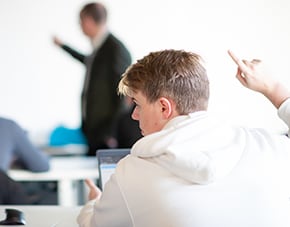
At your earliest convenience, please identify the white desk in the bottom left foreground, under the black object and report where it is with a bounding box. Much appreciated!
[0,205,81,227]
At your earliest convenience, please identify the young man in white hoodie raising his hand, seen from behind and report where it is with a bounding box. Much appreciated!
[78,50,290,227]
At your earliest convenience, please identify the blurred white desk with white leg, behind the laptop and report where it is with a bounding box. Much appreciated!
[8,156,99,206]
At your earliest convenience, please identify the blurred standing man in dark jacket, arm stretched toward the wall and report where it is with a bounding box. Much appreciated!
[54,3,131,155]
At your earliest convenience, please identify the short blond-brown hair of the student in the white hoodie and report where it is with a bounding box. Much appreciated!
[118,50,209,114]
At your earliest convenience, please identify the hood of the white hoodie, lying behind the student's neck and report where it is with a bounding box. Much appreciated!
[131,111,246,184]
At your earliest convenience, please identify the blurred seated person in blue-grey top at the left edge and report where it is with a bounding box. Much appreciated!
[0,118,49,172]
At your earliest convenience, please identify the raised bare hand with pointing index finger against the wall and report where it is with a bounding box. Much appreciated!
[228,50,290,109]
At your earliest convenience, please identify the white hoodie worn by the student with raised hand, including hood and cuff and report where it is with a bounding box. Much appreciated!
[78,100,290,227]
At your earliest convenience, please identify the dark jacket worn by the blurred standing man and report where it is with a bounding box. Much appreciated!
[62,34,131,155]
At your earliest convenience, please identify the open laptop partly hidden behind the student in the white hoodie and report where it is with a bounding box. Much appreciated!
[96,148,130,190]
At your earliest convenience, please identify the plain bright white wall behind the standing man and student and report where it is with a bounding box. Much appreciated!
[0,0,290,138]
